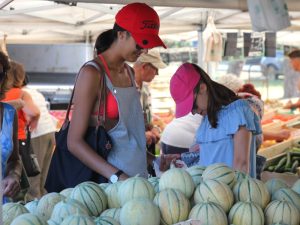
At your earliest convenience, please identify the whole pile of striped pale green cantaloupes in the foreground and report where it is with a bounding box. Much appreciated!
[3,164,300,225]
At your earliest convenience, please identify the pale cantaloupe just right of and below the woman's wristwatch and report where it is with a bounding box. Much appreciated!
[118,177,155,206]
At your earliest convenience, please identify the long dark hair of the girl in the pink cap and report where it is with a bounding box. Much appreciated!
[193,64,240,128]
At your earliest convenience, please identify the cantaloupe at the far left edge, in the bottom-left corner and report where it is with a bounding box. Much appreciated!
[2,202,29,225]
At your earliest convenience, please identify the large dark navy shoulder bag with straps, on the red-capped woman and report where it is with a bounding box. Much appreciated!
[45,60,112,192]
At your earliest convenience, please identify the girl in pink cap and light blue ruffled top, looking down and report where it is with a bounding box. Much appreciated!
[170,63,261,177]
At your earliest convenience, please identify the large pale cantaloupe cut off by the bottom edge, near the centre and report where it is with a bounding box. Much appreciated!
[120,198,160,225]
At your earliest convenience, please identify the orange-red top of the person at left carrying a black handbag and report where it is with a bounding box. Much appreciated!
[2,88,27,140]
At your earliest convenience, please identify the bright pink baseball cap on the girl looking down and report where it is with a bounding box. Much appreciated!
[170,63,200,118]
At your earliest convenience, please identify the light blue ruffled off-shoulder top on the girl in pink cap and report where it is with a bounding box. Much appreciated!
[196,99,262,177]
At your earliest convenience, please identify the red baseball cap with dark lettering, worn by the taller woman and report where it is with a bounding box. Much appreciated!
[115,3,167,49]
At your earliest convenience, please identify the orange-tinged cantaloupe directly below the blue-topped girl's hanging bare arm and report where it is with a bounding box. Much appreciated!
[233,177,270,209]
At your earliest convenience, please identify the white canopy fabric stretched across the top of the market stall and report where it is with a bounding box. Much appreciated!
[0,0,300,45]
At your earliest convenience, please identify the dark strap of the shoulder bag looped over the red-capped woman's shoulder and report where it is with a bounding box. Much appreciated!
[64,60,106,127]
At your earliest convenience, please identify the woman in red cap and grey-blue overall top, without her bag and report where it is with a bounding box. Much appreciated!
[68,3,172,182]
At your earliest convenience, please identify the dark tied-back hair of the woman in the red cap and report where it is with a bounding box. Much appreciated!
[94,24,126,55]
